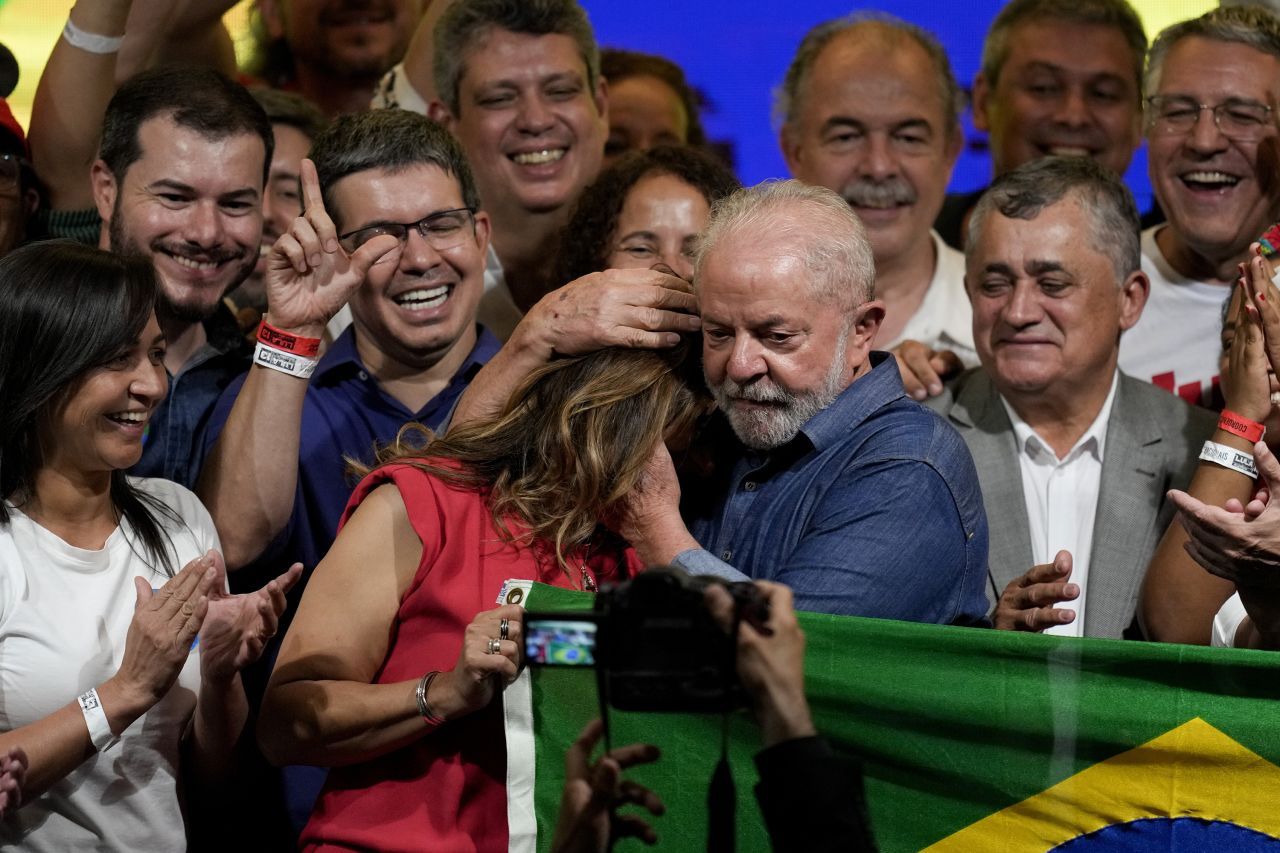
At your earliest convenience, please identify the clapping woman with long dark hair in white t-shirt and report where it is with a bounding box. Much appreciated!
[0,241,298,850]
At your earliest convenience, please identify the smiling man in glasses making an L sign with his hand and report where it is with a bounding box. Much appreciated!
[198,110,499,826]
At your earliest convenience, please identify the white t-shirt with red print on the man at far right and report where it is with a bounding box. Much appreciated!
[1120,225,1231,406]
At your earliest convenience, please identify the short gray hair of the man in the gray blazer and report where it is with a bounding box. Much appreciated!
[965,158,1142,283]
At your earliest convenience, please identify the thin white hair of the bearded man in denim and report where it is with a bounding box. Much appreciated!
[694,181,876,311]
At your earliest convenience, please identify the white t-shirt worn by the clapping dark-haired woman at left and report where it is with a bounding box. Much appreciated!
[0,479,219,853]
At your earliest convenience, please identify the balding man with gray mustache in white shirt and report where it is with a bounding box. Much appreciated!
[777,14,977,398]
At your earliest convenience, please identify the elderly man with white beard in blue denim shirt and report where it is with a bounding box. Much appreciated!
[621,181,987,624]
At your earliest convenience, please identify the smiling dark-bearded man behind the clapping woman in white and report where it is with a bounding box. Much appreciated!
[90,68,274,487]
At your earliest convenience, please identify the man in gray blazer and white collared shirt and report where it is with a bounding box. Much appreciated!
[932,158,1215,638]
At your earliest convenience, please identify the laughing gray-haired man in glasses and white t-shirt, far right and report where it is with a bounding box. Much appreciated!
[1120,6,1280,407]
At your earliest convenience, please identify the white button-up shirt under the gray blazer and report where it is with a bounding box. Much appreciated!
[1000,374,1119,637]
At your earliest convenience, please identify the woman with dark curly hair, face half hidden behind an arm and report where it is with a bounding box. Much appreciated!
[556,146,742,282]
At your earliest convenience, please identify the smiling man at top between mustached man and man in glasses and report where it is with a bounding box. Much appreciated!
[936,0,1147,248]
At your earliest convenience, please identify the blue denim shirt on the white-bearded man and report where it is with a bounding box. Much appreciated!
[675,352,987,624]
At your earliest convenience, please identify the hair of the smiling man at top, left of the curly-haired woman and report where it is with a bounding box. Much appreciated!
[431,0,600,117]
